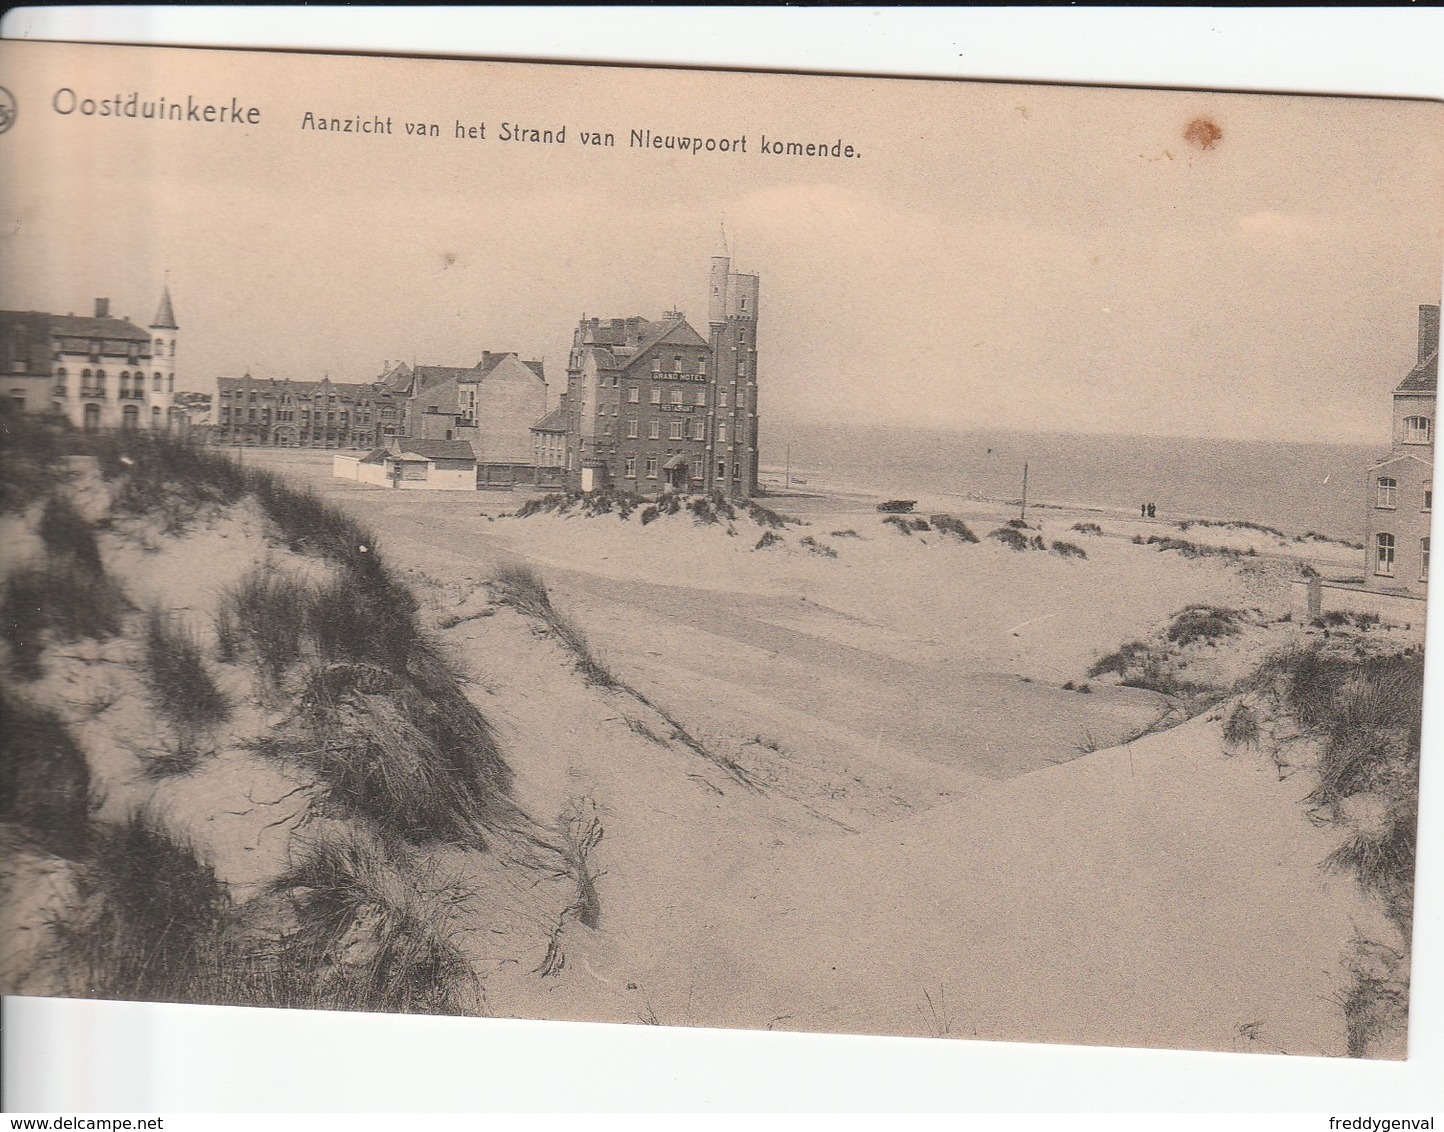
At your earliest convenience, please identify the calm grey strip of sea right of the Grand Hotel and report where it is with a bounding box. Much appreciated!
[762,422,1388,540]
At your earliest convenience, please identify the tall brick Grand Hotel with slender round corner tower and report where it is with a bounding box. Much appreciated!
[563,257,758,497]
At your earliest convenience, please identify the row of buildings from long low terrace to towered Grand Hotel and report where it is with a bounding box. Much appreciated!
[206,256,760,497]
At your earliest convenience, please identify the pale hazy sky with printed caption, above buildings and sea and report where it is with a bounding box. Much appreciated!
[0,43,1444,443]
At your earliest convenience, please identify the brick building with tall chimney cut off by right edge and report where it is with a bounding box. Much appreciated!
[1365,306,1440,596]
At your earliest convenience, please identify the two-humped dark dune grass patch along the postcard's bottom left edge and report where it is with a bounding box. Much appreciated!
[52,813,481,1014]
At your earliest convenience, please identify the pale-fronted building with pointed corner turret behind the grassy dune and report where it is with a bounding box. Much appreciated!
[0,287,189,432]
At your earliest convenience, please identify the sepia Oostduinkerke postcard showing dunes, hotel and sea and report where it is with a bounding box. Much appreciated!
[0,35,1444,1058]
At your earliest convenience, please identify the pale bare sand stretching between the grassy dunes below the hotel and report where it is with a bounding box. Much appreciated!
[166,450,1379,1054]
